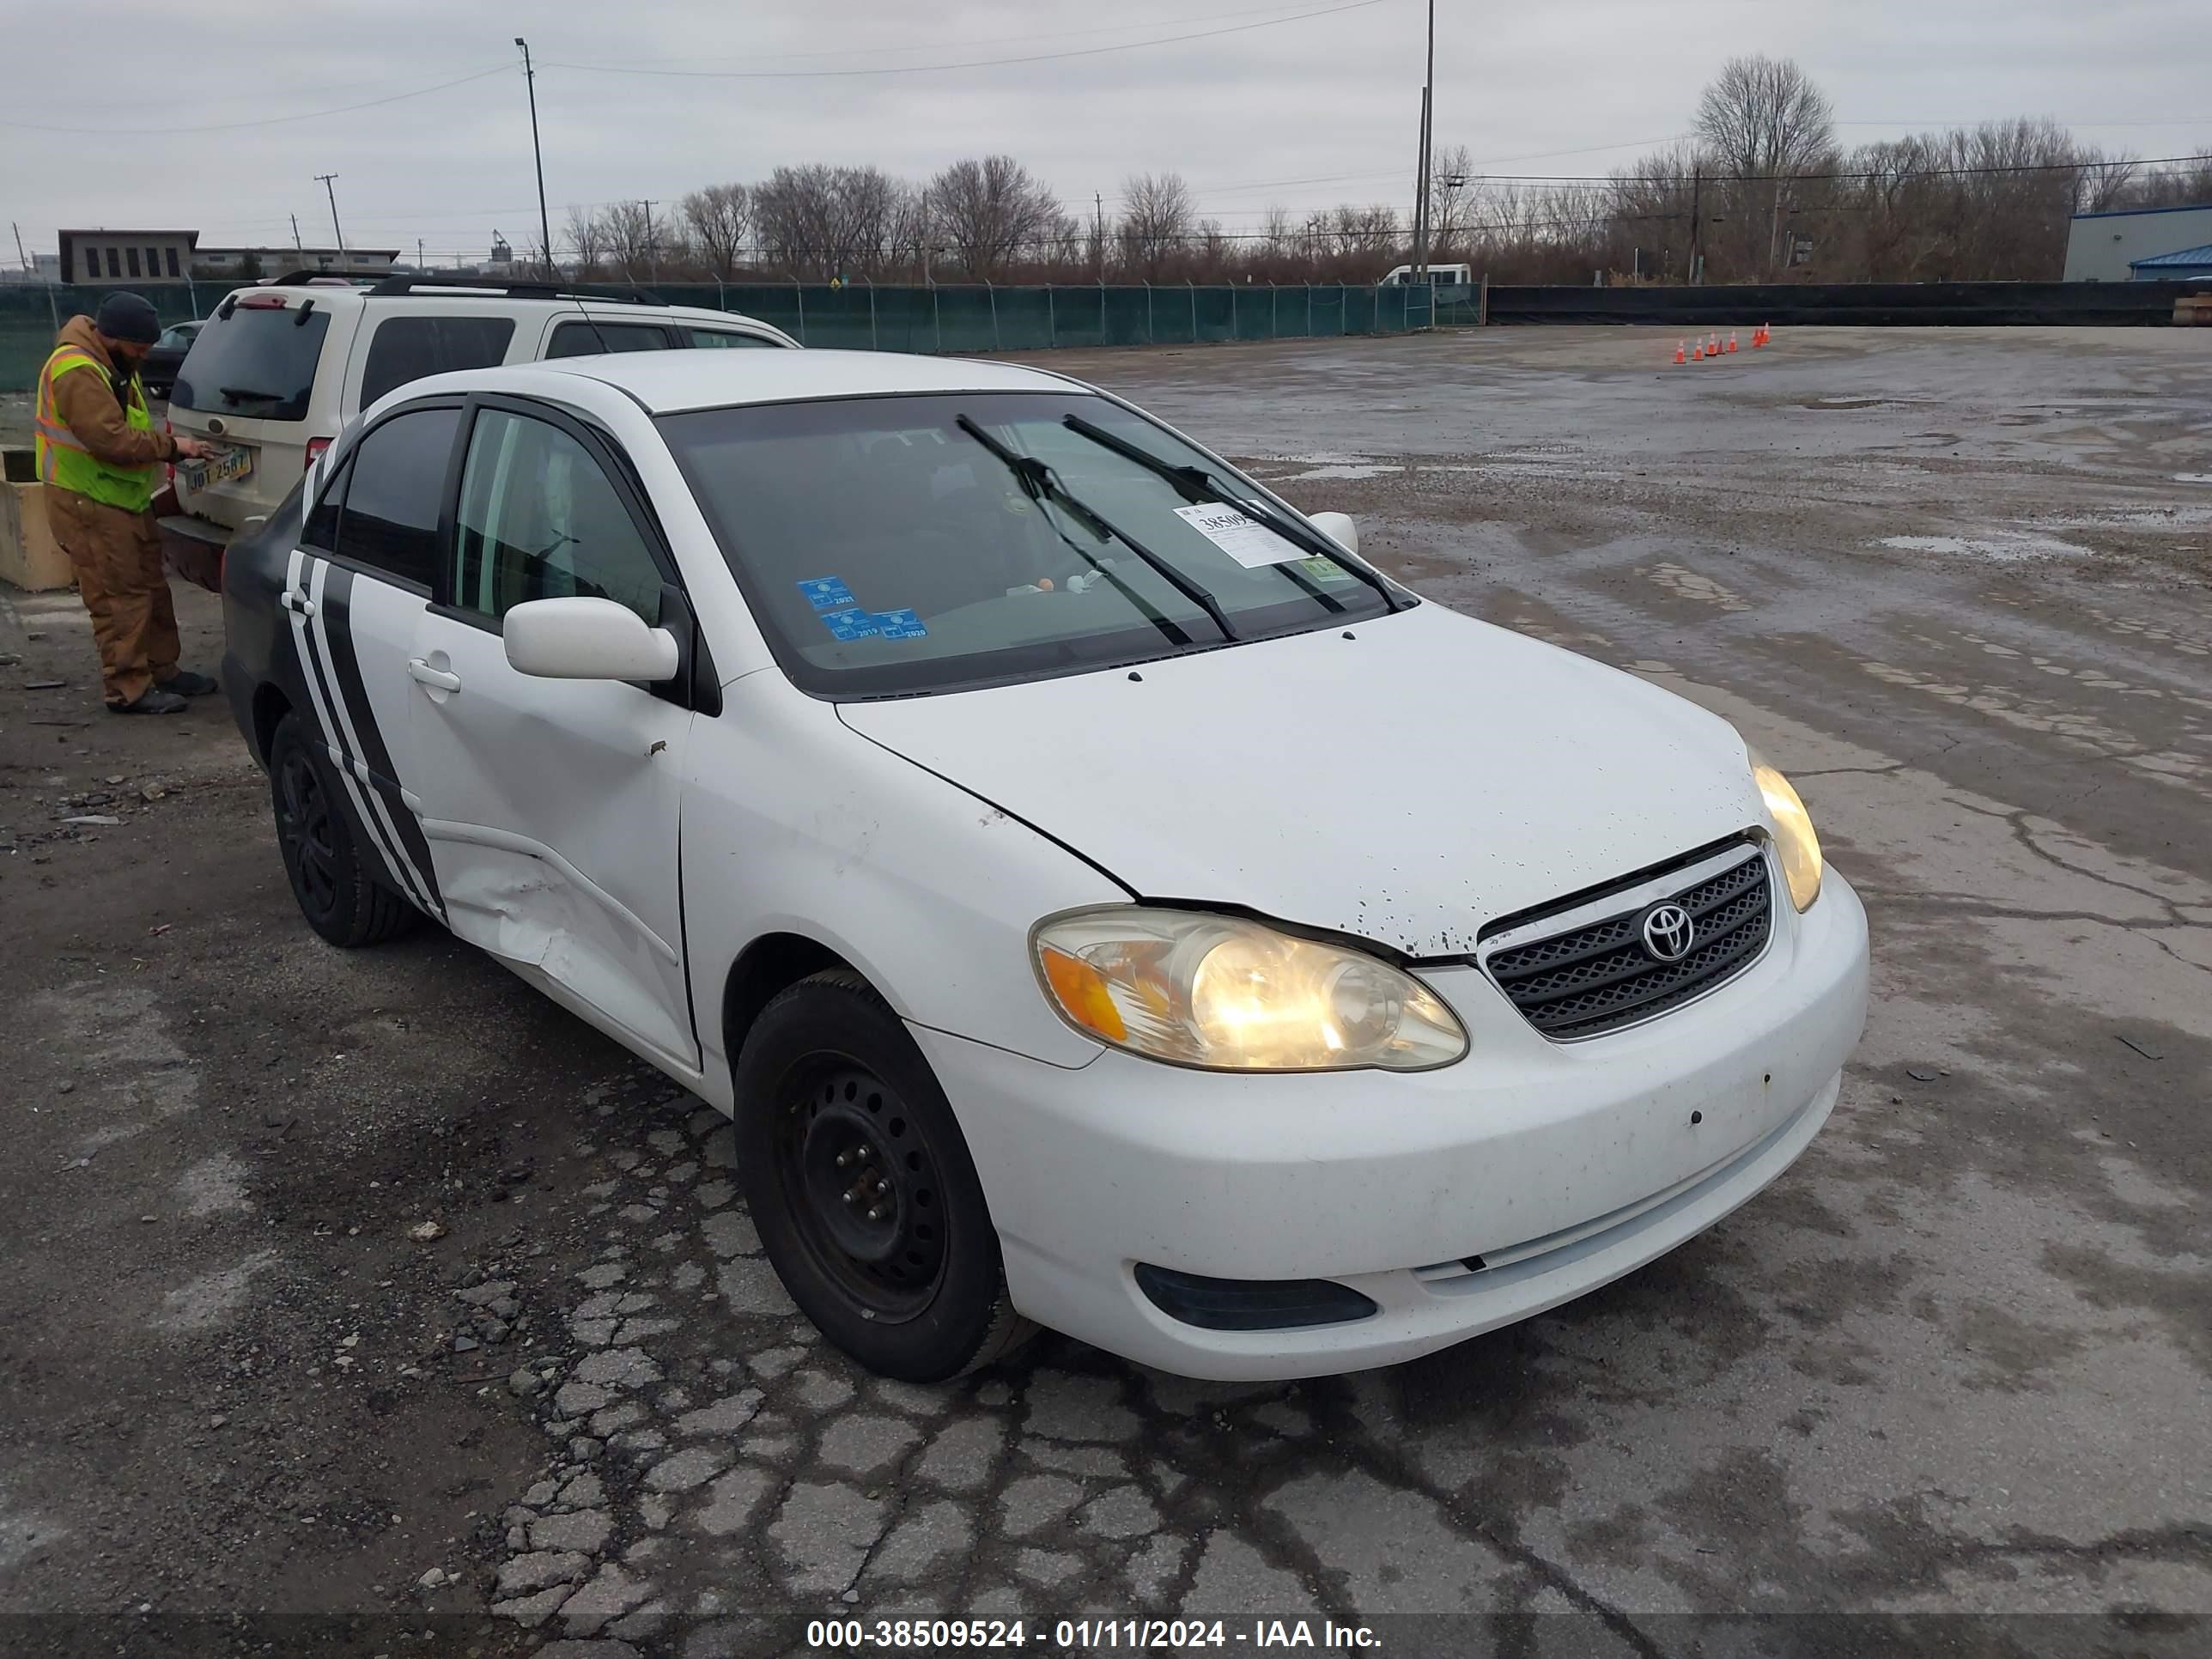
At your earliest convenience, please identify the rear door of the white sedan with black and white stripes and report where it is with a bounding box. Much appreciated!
[279,398,462,918]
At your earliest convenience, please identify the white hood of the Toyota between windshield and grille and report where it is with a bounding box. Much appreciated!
[841,604,1765,957]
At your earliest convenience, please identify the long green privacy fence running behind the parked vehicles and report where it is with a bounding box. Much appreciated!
[0,279,1429,392]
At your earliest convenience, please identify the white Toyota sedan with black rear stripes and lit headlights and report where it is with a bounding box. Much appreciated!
[223,352,1867,1380]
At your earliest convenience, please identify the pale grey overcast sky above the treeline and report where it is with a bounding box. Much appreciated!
[0,0,2212,258]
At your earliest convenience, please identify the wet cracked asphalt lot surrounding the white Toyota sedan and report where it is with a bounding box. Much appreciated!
[0,319,2212,1659]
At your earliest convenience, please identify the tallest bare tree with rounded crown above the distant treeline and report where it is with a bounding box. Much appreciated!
[1694,55,1836,276]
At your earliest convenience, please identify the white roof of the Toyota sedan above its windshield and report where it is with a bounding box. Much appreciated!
[486,349,1088,414]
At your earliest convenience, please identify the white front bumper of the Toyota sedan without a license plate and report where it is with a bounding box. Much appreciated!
[915,872,1867,1378]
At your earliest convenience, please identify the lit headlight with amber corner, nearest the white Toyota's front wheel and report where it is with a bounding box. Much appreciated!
[1033,907,1467,1071]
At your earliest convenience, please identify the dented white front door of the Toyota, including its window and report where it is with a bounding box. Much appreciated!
[407,398,699,1071]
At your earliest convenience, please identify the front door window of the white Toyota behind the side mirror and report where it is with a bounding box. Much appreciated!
[453,410,661,623]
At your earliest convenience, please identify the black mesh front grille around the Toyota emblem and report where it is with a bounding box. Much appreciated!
[1486,849,1774,1037]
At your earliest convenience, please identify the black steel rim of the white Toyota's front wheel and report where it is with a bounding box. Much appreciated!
[775,1055,947,1325]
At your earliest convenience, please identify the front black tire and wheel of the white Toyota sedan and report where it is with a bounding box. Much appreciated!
[732,971,1036,1382]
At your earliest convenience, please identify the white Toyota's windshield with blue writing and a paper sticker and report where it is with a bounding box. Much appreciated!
[659,392,1387,696]
